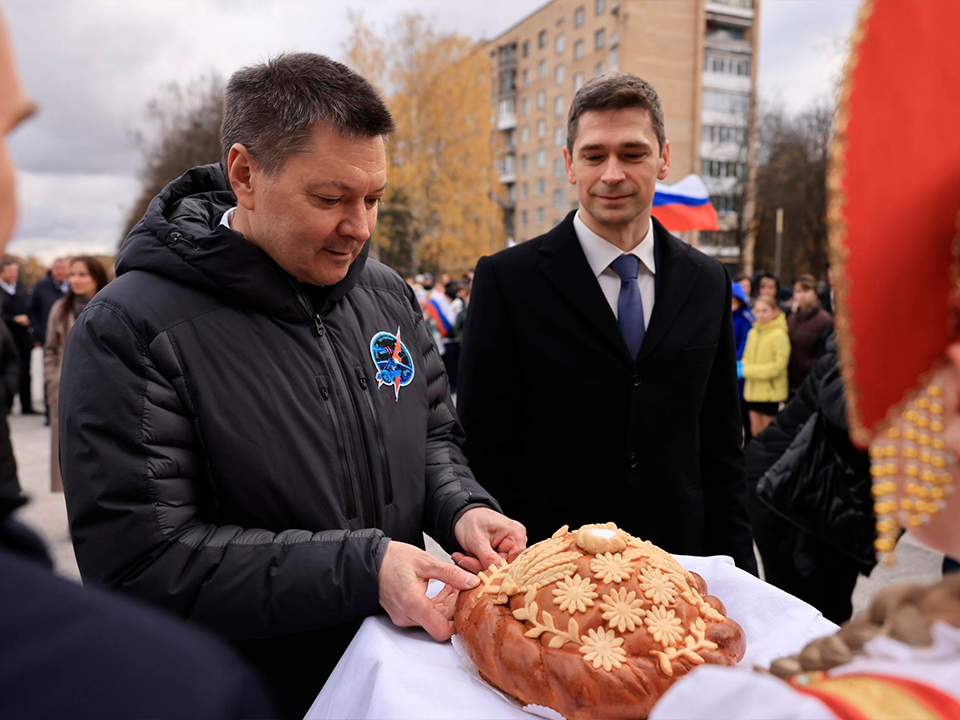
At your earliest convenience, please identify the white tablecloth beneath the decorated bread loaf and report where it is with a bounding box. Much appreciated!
[307,555,837,720]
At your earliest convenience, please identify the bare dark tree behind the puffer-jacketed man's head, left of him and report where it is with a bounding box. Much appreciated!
[120,74,224,242]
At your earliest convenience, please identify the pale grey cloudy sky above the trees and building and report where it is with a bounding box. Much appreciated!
[0,0,859,262]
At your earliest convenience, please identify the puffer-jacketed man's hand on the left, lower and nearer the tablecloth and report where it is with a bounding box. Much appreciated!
[377,540,480,642]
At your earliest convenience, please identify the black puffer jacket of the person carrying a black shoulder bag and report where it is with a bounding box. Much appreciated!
[745,335,875,575]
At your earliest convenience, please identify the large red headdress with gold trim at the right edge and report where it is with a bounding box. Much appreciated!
[829,0,960,444]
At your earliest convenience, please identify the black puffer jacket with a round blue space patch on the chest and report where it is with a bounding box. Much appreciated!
[60,165,499,710]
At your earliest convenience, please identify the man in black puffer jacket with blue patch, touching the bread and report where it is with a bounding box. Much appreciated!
[60,53,526,716]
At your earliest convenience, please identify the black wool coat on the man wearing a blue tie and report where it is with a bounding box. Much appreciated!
[458,212,756,573]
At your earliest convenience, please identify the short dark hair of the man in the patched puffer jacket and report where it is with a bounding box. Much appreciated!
[220,53,395,175]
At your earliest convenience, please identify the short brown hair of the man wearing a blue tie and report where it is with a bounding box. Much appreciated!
[567,72,667,157]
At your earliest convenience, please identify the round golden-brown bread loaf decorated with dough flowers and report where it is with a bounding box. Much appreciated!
[455,523,746,720]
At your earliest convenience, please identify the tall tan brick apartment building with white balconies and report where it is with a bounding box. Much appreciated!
[488,0,757,264]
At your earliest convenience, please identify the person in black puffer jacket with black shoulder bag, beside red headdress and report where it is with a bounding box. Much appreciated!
[745,334,875,623]
